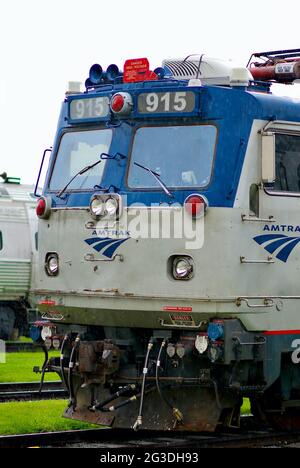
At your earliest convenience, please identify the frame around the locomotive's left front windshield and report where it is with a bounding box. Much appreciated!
[45,125,114,194]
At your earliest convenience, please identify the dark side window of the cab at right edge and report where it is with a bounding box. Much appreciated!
[274,133,300,192]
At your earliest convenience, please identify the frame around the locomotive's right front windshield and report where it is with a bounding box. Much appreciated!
[125,121,219,192]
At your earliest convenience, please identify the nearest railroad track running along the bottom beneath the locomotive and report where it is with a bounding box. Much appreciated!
[0,429,300,452]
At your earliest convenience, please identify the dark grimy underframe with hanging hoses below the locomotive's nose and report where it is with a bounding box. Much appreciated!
[36,319,300,431]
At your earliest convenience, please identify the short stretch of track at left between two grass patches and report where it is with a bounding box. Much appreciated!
[0,382,67,403]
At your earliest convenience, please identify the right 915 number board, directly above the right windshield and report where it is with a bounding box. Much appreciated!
[138,91,196,114]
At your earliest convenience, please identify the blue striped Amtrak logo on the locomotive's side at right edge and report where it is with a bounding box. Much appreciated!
[254,234,300,263]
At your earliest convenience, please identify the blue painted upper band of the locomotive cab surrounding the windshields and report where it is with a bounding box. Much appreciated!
[44,82,300,208]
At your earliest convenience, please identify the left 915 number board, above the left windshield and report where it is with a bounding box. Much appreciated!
[69,96,109,120]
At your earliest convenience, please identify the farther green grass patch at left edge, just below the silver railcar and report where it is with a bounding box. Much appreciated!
[0,351,59,382]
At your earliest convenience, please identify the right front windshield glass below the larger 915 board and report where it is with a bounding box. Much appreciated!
[128,125,217,188]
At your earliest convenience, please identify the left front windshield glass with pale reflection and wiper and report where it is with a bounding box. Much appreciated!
[49,129,112,190]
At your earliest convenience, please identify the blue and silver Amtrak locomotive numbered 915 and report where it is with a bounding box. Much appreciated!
[33,49,300,431]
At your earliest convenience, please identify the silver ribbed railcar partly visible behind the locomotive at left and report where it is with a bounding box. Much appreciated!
[0,172,38,339]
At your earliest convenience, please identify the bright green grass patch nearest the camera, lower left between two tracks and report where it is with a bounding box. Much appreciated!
[0,400,99,435]
